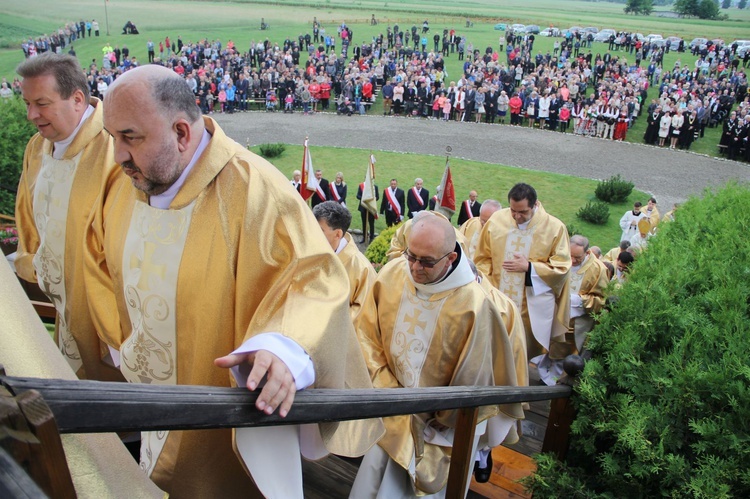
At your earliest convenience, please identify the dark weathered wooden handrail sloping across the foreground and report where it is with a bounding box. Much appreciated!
[0,377,571,433]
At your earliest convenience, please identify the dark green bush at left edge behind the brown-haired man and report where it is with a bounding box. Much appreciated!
[0,97,36,215]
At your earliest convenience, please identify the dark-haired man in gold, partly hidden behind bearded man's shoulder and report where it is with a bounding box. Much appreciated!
[313,201,378,322]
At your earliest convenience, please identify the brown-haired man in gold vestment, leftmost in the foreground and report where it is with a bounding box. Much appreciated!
[15,53,123,381]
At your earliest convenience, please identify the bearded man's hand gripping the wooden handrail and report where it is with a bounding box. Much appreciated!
[214,350,297,418]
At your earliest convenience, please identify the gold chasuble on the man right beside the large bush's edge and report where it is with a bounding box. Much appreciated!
[570,251,609,352]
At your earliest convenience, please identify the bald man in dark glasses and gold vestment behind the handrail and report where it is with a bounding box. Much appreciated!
[350,212,523,498]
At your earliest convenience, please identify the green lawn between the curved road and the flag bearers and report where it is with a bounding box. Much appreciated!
[251,144,649,252]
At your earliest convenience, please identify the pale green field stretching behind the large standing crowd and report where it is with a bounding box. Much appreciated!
[0,0,750,156]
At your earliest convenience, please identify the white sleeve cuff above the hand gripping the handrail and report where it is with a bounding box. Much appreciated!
[230,333,315,391]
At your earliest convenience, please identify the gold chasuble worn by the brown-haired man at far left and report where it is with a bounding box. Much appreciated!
[15,98,123,381]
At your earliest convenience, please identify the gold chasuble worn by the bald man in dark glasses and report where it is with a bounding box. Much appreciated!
[353,252,523,497]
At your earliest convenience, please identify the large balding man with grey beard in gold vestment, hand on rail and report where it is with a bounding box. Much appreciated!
[86,65,382,498]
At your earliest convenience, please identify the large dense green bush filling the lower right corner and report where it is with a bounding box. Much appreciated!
[526,184,750,498]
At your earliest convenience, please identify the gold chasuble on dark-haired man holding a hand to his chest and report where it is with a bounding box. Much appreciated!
[474,203,571,359]
